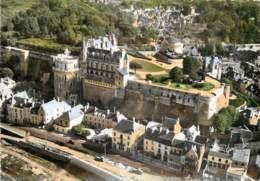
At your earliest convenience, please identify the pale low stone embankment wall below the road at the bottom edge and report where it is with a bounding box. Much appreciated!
[71,156,126,181]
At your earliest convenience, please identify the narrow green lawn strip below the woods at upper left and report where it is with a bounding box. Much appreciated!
[18,38,80,52]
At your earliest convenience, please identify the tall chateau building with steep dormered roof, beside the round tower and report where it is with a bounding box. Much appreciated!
[81,35,129,102]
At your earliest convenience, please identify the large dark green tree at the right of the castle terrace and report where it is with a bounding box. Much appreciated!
[183,57,201,80]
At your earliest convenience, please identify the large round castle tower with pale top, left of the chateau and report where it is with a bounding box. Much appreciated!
[53,49,80,105]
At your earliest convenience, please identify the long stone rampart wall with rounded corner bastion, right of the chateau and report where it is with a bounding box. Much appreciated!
[121,78,230,126]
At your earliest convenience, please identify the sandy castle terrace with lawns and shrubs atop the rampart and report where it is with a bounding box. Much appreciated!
[129,56,221,96]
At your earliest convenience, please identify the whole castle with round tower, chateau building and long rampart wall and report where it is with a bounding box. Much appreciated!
[53,35,230,126]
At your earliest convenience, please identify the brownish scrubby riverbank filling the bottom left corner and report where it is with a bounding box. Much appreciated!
[0,143,102,181]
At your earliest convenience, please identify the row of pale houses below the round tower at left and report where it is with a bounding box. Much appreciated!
[5,88,126,133]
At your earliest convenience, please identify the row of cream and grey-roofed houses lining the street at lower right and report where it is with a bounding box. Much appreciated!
[112,117,260,181]
